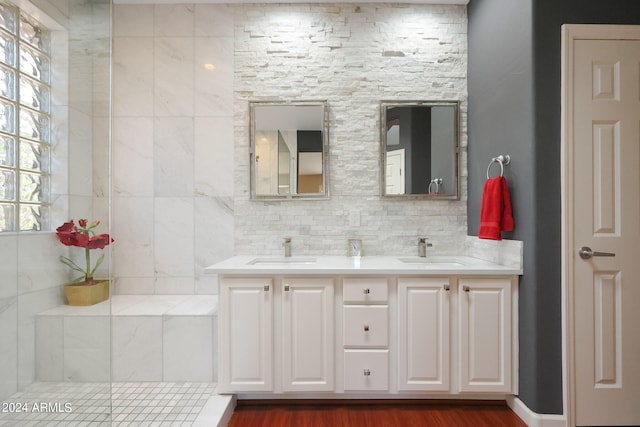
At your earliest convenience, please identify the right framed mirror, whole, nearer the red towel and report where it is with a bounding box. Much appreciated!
[380,101,459,199]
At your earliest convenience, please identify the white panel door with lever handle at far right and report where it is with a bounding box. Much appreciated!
[567,31,640,426]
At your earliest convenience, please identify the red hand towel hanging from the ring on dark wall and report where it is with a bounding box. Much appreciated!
[478,176,514,240]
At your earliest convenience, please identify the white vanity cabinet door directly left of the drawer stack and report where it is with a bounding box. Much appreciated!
[282,278,335,391]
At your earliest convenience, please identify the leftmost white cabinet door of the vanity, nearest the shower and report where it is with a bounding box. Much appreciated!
[218,278,273,391]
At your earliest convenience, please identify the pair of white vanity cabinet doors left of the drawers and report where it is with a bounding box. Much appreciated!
[218,277,335,392]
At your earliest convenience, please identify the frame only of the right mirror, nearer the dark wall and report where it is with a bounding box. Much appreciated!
[379,100,460,200]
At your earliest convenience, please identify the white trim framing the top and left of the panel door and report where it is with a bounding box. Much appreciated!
[560,24,640,426]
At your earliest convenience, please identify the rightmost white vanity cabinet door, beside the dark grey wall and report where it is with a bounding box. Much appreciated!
[458,279,512,392]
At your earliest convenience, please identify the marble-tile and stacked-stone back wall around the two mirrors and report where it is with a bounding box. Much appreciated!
[113,4,467,294]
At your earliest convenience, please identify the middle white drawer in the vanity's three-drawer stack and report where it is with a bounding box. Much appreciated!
[342,305,389,347]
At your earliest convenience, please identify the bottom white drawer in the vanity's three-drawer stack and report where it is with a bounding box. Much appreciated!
[344,350,389,391]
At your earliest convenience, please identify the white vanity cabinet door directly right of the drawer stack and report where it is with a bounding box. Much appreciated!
[398,277,451,391]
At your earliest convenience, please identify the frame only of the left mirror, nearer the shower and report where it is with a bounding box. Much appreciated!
[249,100,329,200]
